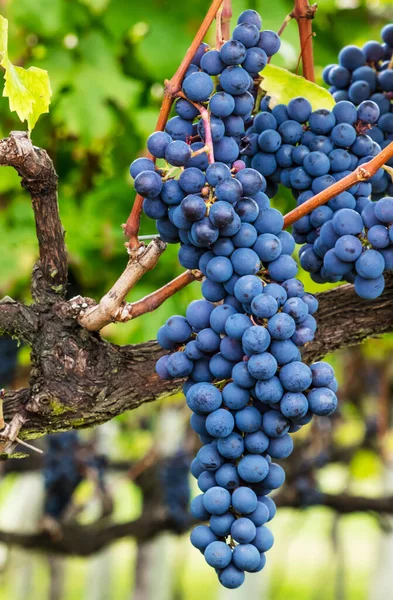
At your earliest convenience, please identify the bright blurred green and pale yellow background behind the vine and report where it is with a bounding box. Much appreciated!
[0,0,393,600]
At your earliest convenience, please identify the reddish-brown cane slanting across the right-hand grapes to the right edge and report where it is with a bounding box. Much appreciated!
[284,142,393,229]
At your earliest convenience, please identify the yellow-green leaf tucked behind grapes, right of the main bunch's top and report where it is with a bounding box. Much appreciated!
[260,65,336,110]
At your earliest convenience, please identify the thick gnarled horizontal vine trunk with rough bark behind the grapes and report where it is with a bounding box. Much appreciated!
[0,274,393,438]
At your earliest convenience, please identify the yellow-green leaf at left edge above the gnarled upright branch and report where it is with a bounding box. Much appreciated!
[0,15,52,131]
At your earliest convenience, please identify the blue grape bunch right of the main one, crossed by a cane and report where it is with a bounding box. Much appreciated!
[236,98,393,299]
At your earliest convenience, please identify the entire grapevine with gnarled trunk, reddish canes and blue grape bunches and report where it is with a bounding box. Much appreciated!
[0,0,393,576]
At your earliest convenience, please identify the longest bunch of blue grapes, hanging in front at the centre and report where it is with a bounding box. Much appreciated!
[130,10,340,588]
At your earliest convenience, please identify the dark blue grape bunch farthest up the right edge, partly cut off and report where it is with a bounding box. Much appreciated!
[322,23,393,197]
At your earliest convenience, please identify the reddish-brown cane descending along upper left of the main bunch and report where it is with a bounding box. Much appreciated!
[124,0,224,250]
